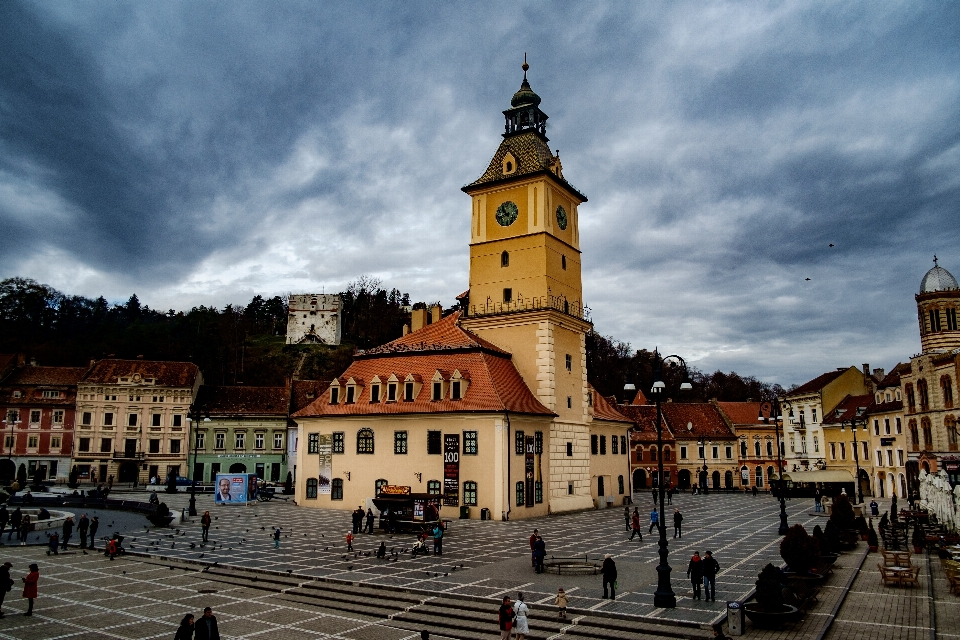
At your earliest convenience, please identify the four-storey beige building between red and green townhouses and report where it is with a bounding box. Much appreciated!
[73,359,203,483]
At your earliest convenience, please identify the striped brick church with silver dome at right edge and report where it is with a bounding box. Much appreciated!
[901,256,960,487]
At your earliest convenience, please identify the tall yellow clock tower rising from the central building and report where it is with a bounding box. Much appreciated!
[461,62,592,512]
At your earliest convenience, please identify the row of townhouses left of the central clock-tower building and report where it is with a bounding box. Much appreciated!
[0,355,325,484]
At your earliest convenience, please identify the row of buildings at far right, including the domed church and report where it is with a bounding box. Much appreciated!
[780,264,960,497]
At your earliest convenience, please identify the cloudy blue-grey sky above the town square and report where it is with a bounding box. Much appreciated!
[0,1,960,386]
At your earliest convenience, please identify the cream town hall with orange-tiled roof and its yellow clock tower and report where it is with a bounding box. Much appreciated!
[294,62,631,518]
